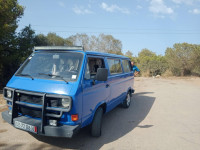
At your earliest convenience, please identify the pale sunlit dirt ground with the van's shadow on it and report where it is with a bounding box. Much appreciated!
[0,77,200,150]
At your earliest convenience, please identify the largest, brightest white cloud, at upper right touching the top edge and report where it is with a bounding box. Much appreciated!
[149,0,174,15]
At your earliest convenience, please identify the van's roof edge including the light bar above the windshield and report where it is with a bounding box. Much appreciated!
[34,46,129,59]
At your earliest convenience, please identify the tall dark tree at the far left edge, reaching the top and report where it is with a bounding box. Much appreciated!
[0,0,24,87]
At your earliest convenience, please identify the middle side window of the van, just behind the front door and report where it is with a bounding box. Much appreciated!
[107,59,122,74]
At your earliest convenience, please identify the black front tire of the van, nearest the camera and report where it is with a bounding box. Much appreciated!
[91,107,103,137]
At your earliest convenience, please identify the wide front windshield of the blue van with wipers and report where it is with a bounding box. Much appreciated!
[15,51,83,82]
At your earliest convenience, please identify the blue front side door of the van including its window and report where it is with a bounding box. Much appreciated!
[82,56,110,126]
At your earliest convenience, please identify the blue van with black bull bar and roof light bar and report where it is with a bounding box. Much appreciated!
[2,46,134,137]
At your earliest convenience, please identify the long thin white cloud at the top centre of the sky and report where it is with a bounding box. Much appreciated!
[101,2,130,14]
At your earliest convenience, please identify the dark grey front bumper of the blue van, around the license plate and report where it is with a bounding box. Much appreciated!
[2,111,80,138]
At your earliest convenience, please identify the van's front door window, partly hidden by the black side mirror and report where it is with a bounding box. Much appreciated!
[84,57,105,80]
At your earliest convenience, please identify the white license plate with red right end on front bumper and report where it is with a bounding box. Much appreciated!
[14,121,37,133]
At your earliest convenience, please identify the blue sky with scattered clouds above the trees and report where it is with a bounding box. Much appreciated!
[17,0,200,56]
